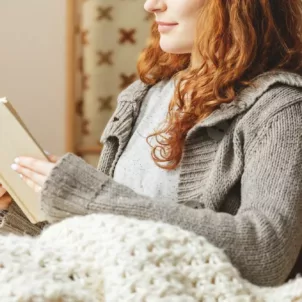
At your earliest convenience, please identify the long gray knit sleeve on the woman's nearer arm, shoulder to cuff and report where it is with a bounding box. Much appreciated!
[41,105,302,286]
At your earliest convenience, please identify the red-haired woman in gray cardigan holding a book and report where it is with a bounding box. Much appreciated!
[2,0,302,285]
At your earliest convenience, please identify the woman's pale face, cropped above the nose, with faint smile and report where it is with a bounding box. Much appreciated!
[144,0,206,54]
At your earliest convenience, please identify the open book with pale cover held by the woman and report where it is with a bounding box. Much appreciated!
[0,98,49,223]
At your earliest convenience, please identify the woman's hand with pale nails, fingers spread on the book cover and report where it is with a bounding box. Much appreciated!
[11,155,59,192]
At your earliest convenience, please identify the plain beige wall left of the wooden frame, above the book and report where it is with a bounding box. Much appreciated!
[0,0,66,155]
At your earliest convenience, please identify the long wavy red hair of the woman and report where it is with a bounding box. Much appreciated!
[137,0,302,170]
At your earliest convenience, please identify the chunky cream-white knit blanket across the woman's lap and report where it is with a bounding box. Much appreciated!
[0,214,302,302]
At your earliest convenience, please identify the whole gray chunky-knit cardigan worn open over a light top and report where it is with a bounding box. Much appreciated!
[2,72,302,285]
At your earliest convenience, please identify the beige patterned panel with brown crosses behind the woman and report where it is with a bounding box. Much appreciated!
[75,0,152,166]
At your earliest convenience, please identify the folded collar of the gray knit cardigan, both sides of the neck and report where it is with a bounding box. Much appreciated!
[101,71,302,146]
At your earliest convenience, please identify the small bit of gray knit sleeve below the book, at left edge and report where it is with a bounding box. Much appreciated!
[0,202,47,236]
